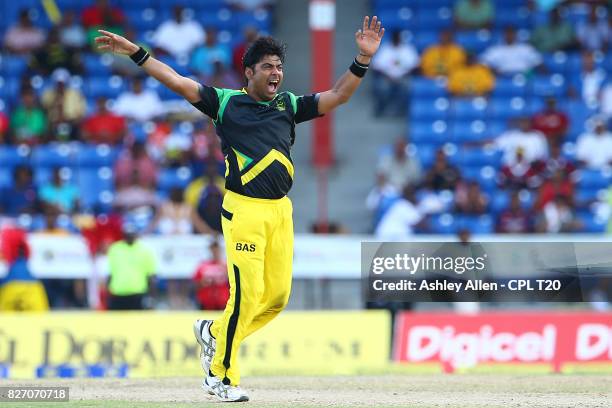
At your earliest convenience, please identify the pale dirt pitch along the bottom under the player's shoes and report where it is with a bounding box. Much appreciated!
[0,374,612,408]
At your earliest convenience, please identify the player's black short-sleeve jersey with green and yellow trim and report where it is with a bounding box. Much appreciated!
[193,85,320,199]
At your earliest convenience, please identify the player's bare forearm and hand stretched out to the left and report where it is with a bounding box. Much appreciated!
[95,30,201,102]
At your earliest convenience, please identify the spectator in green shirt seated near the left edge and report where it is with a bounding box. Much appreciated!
[11,88,47,145]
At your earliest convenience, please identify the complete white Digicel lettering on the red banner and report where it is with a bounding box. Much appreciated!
[407,324,557,367]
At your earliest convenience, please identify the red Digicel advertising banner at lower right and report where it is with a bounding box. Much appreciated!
[393,312,612,372]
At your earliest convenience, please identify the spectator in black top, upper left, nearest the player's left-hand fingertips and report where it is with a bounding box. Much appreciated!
[30,28,83,76]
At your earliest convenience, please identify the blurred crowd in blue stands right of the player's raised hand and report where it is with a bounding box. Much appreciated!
[366,0,612,240]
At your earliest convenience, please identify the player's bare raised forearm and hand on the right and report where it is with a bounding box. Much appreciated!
[319,16,385,115]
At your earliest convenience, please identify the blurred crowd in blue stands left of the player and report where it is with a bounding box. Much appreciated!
[0,0,274,307]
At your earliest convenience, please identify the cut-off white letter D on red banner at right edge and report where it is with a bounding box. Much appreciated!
[576,323,612,361]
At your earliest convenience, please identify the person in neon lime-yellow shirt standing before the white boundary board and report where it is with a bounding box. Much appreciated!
[107,225,156,310]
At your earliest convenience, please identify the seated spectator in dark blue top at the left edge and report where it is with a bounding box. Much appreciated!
[0,166,39,216]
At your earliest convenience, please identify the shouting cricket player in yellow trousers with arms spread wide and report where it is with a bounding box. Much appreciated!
[95,16,384,402]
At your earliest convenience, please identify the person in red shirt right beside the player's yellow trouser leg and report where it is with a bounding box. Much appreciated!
[193,240,229,310]
